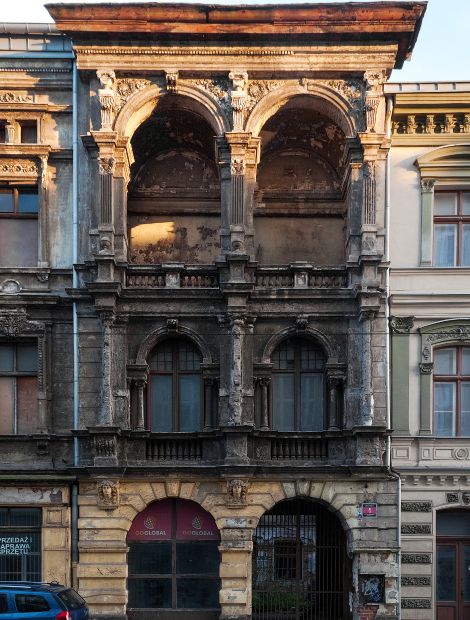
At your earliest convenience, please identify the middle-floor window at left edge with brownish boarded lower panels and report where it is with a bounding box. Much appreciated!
[0,343,38,435]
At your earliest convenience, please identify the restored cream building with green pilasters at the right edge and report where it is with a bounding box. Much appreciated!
[386,82,470,620]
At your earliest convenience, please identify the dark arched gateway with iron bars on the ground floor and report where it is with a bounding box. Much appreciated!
[253,498,352,620]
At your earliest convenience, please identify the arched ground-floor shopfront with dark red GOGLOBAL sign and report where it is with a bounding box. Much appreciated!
[127,499,220,620]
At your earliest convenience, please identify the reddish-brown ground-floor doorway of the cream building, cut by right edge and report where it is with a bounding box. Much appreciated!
[436,509,470,620]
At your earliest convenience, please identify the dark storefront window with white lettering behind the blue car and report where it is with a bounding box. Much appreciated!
[0,508,41,581]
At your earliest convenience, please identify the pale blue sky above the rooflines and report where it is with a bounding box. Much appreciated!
[0,0,470,82]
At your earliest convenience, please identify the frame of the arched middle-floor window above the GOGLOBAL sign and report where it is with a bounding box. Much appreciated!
[146,338,204,433]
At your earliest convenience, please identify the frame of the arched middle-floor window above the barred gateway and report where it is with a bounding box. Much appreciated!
[270,336,327,433]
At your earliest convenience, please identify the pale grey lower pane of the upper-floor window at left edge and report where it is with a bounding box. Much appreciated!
[0,217,38,267]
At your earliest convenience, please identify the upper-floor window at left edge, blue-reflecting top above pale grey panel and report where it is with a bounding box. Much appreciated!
[0,185,39,267]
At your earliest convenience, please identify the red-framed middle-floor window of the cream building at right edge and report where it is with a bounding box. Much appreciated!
[434,347,470,437]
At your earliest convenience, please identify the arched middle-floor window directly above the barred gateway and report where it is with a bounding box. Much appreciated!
[272,338,325,431]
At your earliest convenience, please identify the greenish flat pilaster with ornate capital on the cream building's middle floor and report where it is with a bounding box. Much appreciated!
[390,316,414,434]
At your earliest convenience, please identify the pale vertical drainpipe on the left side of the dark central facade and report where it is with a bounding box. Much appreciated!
[71,58,79,587]
